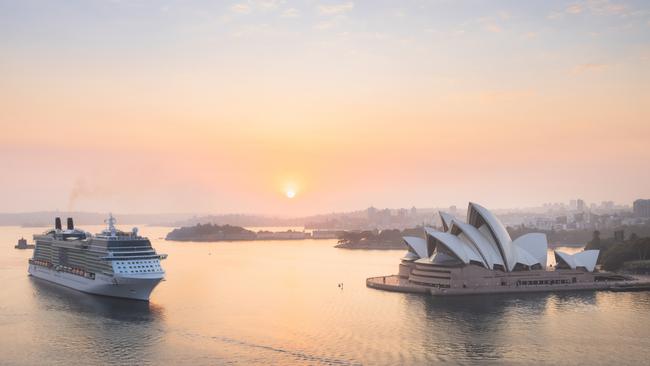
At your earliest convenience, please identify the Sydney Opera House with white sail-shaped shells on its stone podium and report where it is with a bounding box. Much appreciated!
[366,203,620,295]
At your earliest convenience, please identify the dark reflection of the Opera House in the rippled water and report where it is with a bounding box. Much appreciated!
[407,292,602,363]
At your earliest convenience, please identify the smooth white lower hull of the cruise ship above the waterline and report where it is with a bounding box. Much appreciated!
[29,264,162,301]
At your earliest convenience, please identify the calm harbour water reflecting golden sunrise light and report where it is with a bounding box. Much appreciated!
[0,227,650,365]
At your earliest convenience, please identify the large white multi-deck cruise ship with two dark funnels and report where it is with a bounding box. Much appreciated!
[29,215,167,301]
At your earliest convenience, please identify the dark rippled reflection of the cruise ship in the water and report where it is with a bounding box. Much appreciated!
[27,277,165,365]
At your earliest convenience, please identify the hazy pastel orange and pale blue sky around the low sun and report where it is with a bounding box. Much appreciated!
[0,0,650,215]
